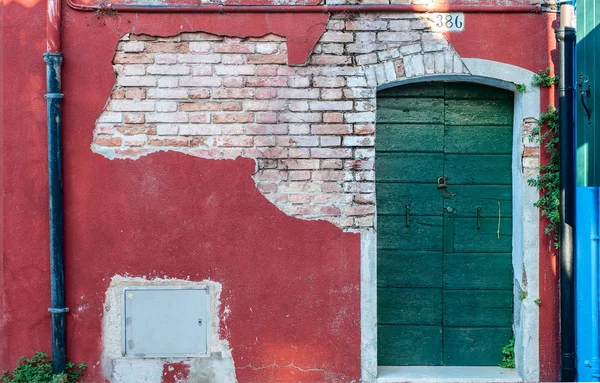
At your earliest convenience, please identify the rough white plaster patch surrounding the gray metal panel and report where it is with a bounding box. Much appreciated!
[102,275,237,383]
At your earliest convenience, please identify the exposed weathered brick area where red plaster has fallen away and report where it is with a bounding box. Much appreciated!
[92,14,480,230]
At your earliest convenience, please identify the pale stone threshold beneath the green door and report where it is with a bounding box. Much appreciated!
[376,366,523,383]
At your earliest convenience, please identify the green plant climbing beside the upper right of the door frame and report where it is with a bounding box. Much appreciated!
[527,105,560,248]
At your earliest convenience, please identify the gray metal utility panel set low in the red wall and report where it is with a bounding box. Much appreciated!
[123,286,210,357]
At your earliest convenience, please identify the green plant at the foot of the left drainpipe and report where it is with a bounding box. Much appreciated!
[0,351,87,383]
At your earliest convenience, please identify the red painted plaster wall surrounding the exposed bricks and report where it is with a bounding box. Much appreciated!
[0,2,557,382]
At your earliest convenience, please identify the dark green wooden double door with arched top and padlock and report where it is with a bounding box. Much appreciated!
[375,82,513,366]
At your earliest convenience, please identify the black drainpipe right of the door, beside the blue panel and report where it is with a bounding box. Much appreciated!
[556,18,576,382]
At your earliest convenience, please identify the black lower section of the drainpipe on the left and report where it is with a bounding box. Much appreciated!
[44,52,69,374]
